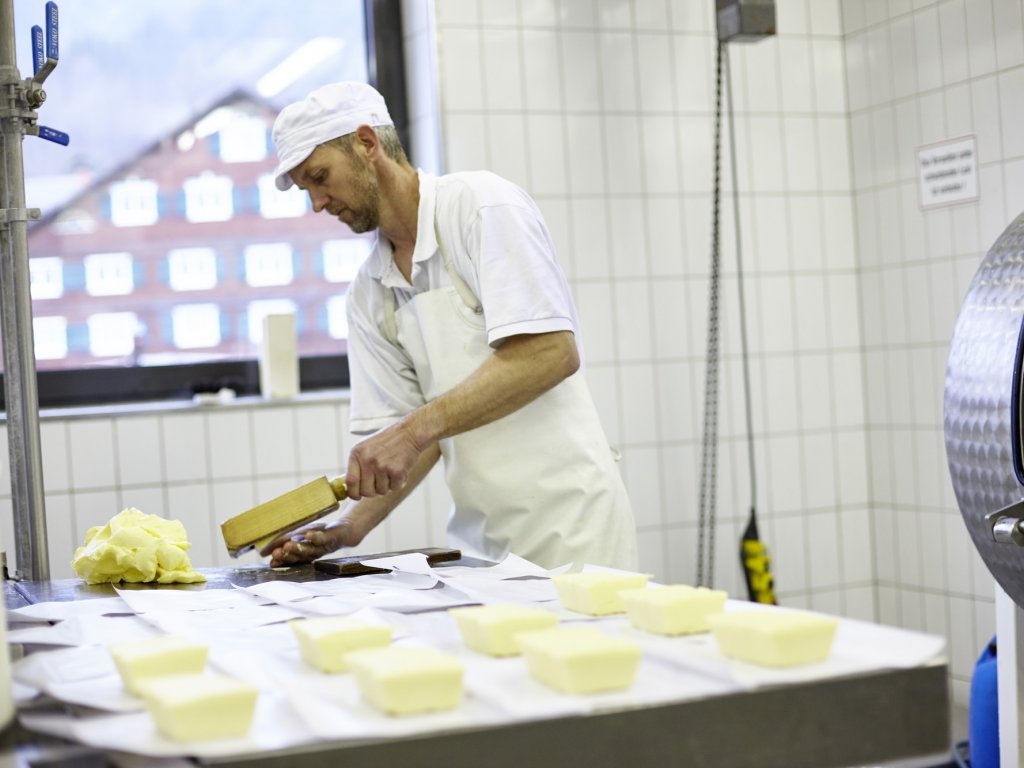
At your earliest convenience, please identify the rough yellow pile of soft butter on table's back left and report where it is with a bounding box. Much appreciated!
[71,507,206,584]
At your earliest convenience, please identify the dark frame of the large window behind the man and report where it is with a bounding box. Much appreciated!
[12,0,405,409]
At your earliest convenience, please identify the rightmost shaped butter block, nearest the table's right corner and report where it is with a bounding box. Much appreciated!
[708,610,839,667]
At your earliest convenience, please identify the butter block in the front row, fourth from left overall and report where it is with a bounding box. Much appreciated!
[347,646,464,715]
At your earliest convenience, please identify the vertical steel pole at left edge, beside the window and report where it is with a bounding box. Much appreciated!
[0,0,50,581]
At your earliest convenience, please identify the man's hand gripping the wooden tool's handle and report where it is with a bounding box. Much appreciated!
[345,419,423,499]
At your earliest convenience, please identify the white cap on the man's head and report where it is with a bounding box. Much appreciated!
[273,82,394,190]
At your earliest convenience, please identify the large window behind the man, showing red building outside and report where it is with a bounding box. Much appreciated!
[17,0,403,406]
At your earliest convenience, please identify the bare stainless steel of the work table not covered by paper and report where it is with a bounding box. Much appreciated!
[5,561,950,768]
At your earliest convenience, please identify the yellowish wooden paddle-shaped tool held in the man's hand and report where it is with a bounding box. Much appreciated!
[220,477,347,557]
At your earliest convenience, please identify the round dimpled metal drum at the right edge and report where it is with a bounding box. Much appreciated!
[943,214,1024,606]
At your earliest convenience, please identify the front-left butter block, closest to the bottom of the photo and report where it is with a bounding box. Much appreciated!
[141,674,259,741]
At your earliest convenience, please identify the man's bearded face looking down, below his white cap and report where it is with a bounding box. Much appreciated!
[291,144,380,233]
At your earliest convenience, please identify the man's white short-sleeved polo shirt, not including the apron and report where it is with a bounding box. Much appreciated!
[347,171,583,434]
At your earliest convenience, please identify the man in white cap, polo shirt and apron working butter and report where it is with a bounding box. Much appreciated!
[262,82,637,568]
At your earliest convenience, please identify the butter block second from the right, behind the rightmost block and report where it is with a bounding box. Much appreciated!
[620,584,729,635]
